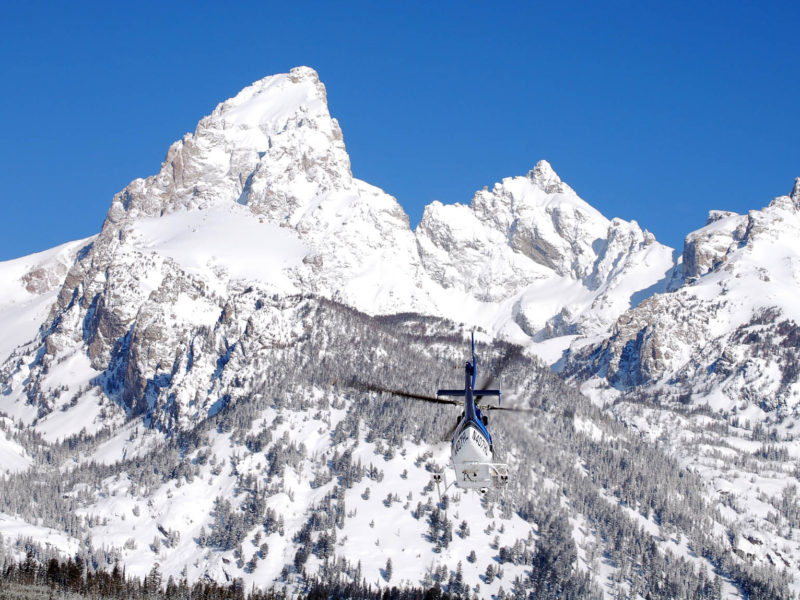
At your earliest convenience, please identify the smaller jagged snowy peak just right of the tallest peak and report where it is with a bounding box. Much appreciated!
[417,161,673,339]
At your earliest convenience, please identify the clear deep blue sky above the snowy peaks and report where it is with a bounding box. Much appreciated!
[0,1,800,260]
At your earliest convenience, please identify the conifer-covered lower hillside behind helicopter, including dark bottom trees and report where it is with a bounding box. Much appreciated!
[0,297,793,599]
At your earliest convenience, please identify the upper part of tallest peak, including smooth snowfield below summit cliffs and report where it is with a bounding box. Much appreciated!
[98,67,438,312]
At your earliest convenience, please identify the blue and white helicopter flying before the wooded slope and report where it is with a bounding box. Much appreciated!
[362,333,529,494]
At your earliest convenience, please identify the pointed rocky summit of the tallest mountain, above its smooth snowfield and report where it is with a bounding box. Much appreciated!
[105,67,353,228]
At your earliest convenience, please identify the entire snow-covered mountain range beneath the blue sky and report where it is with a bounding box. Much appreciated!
[0,67,800,598]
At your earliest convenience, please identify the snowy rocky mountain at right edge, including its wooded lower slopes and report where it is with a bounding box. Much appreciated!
[562,179,800,592]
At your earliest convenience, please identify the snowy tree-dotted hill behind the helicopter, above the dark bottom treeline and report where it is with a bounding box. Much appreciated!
[4,310,760,597]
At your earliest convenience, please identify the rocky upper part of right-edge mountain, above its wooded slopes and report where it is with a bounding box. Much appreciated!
[567,184,800,416]
